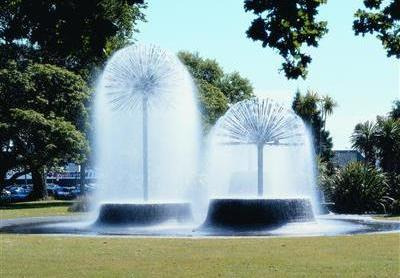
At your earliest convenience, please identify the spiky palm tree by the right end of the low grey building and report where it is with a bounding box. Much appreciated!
[351,121,377,166]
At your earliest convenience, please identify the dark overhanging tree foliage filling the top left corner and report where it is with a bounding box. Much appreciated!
[0,0,146,77]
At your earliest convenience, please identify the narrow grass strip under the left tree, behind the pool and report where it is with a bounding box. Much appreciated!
[0,200,73,219]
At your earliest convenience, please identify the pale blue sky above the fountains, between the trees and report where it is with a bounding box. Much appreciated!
[136,0,400,149]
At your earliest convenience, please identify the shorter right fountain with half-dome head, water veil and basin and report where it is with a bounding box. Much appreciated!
[204,98,316,229]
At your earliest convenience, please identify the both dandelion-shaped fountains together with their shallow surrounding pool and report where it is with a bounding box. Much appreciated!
[0,45,400,237]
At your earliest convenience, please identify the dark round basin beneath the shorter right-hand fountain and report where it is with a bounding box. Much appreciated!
[202,199,315,229]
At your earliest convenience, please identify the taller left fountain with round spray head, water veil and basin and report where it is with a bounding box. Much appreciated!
[96,45,199,225]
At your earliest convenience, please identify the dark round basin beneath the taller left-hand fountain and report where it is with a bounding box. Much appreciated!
[96,203,192,226]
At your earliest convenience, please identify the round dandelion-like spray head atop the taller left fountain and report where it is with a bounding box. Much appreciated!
[103,45,182,111]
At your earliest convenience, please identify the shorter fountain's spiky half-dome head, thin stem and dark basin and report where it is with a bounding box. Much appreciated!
[203,98,314,229]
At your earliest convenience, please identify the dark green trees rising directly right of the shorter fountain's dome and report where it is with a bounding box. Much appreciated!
[292,91,336,162]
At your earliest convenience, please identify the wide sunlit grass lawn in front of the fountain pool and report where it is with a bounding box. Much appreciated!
[0,234,400,277]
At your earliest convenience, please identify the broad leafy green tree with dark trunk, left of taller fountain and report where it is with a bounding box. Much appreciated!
[0,64,90,198]
